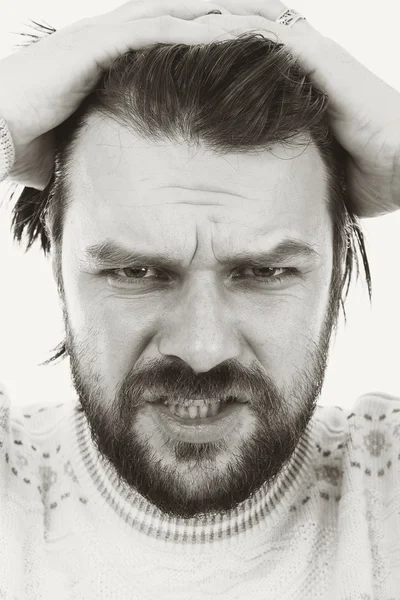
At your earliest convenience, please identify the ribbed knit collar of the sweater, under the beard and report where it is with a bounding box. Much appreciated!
[71,411,315,543]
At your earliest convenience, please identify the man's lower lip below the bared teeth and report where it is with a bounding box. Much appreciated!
[152,402,245,444]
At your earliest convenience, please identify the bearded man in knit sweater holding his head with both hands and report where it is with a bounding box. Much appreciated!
[0,0,400,600]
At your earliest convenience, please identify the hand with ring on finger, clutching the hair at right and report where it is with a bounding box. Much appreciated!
[196,0,400,217]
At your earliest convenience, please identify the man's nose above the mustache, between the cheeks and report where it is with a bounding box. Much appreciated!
[158,282,241,373]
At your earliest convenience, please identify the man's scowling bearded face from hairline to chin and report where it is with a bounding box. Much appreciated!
[54,118,332,518]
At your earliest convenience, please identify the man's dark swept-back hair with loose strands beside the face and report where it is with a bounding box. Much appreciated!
[4,23,371,364]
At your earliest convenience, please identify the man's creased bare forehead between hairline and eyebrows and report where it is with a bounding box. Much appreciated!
[64,116,329,253]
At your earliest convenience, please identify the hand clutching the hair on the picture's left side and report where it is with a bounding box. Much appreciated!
[0,0,233,190]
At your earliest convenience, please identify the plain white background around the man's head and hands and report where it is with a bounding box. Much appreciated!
[0,0,400,408]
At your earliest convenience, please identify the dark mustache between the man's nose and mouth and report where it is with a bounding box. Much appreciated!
[117,359,279,404]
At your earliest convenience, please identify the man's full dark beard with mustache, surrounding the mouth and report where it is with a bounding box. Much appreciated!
[63,302,336,518]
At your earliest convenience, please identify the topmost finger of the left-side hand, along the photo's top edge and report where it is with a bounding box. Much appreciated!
[96,0,228,23]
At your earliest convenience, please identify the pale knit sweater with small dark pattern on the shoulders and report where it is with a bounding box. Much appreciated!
[0,386,400,600]
